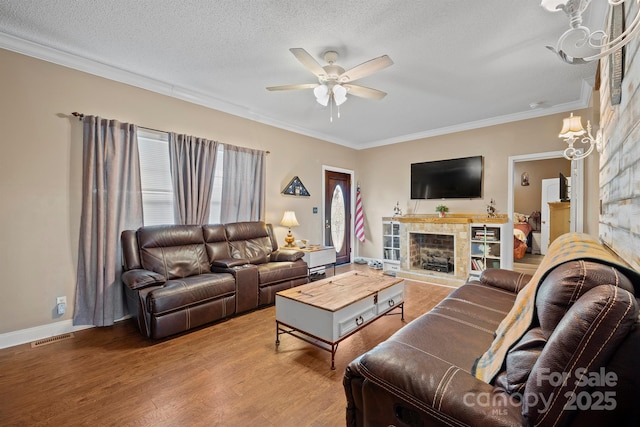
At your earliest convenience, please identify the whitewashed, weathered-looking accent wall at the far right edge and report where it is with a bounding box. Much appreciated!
[596,2,640,270]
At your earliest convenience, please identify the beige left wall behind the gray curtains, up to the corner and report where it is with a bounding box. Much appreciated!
[0,50,358,334]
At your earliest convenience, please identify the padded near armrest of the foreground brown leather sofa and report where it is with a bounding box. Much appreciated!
[345,341,523,426]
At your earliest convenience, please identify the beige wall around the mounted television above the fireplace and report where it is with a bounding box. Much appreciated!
[358,110,597,258]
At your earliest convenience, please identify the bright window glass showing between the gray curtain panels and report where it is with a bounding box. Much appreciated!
[138,128,223,225]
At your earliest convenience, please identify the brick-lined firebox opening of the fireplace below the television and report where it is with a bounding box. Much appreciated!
[409,233,455,274]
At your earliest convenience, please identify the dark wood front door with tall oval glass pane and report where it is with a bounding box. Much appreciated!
[324,171,351,264]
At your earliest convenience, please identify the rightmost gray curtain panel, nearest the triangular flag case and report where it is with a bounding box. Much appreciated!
[220,144,267,224]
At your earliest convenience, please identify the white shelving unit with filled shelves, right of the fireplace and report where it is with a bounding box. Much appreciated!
[469,224,509,278]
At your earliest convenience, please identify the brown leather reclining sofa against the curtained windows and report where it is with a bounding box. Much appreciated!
[121,221,308,338]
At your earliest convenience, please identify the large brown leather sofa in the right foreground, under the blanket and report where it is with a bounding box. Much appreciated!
[343,234,640,426]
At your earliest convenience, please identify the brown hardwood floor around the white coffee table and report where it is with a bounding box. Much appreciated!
[0,266,452,426]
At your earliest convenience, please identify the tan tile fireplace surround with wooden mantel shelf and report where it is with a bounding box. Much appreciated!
[392,214,508,286]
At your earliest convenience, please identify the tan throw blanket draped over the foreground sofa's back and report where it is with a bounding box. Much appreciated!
[472,233,637,383]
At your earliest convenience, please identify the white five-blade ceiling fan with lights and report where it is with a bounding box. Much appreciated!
[267,47,393,121]
